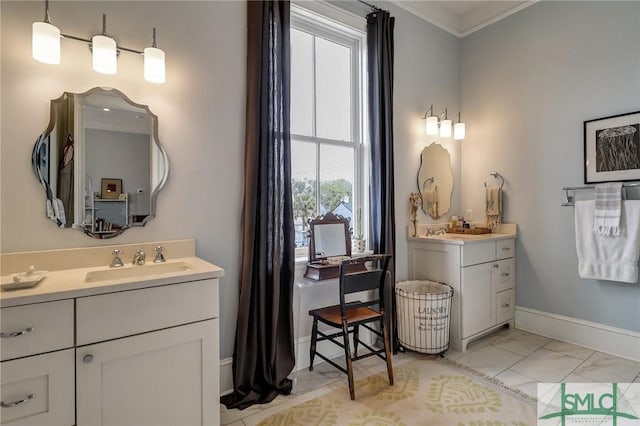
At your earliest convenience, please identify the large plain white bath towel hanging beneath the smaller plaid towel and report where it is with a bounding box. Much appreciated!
[575,200,640,283]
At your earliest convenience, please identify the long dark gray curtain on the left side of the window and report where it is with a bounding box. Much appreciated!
[222,1,295,409]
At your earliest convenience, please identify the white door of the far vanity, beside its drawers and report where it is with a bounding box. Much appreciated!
[460,263,496,338]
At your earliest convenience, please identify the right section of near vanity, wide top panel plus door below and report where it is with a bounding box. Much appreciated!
[75,280,219,426]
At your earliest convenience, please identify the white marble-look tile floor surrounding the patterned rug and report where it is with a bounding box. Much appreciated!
[220,329,640,426]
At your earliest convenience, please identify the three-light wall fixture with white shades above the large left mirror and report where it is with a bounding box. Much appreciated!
[31,0,166,83]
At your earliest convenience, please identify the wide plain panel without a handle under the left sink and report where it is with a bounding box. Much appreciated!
[76,278,218,346]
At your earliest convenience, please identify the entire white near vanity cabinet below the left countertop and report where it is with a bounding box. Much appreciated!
[0,251,222,426]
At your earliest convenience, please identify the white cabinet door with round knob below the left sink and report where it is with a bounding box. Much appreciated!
[76,319,219,426]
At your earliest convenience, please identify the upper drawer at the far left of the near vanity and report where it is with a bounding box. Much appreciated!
[0,299,73,361]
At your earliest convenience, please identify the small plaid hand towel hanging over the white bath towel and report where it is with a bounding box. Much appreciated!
[593,182,622,237]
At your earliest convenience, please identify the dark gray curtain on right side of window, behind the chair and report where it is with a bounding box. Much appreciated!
[367,9,397,348]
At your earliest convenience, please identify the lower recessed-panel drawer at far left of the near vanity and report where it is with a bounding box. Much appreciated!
[0,349,75,426]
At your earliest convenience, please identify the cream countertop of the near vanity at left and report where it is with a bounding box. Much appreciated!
[0,256,224,308]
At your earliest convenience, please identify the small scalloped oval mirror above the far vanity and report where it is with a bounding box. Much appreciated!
[418,143,453,219]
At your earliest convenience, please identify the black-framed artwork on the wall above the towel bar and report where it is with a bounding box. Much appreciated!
[584,111,640,183]
